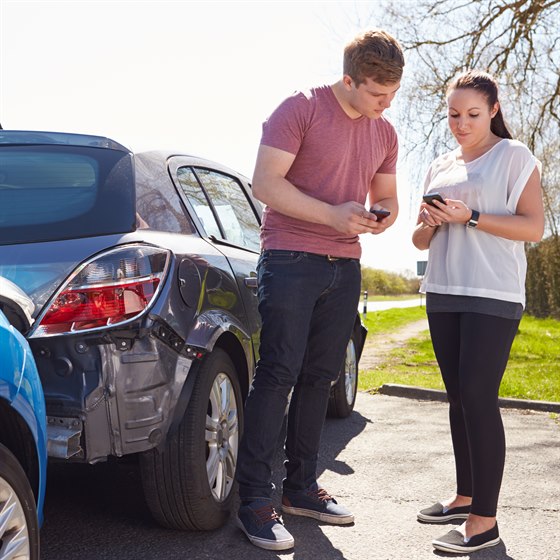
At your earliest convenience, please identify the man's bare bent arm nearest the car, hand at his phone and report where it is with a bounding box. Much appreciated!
[252,145,380,235]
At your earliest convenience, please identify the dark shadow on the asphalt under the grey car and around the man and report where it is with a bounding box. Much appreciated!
[41,406,370,560]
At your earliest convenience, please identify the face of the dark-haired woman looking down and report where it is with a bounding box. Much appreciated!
[447,88,499,149]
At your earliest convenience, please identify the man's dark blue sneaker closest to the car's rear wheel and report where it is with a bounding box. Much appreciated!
[237,500,294,550]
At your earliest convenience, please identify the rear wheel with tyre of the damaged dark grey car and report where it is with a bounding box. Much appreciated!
[140,349,243,530]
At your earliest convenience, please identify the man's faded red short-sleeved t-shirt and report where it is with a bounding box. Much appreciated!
[261,86,398,258]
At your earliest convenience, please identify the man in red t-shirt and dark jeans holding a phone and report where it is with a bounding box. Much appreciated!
[237,30,404,550]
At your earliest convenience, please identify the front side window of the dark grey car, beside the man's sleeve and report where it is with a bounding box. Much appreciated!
[195,168,260,251]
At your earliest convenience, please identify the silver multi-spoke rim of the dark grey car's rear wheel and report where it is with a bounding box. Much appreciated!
[206,373,239,502]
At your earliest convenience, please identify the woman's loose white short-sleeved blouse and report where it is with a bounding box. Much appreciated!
[420,139,540,306]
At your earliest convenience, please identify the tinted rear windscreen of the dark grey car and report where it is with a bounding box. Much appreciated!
[0,145,134,244]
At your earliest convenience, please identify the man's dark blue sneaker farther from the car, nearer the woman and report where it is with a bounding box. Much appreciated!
[282,483,354,525]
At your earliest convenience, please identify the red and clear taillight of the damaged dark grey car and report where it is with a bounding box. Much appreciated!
[33,246,169,336]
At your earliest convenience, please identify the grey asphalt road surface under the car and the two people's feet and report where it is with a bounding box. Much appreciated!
[41,393,560,560]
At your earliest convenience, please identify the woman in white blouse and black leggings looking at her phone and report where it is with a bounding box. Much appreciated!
[413,71,544,554]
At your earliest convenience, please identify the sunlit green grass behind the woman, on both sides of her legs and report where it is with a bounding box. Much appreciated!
[359,308,560,402]
